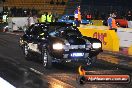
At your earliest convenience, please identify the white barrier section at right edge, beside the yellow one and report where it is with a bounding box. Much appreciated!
[117,28,132,47]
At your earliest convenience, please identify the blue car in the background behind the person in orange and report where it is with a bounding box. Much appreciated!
[58,15,93,24]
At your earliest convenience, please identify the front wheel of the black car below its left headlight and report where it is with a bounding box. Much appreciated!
[42,49,52,69]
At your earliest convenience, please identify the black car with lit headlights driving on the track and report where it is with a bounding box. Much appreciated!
[20,22,102,68]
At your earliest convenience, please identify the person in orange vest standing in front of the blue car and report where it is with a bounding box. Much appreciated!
[74,6,82,27]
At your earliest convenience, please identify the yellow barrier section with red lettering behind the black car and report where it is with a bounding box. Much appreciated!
[79,27,119,52]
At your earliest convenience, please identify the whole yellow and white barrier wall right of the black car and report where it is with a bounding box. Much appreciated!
[79,25,132,55]
